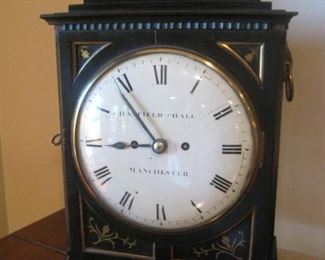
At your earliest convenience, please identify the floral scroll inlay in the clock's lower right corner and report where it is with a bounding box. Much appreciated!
[193,231,243,260]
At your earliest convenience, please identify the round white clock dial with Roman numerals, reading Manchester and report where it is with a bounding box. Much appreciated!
[73,48,258,232]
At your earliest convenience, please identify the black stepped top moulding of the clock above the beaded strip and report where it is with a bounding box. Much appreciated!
[41,0,297,24]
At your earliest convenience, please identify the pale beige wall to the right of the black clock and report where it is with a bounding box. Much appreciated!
[272,0,325,259]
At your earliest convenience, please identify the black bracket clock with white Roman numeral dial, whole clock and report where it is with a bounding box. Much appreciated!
[42,0,296,260]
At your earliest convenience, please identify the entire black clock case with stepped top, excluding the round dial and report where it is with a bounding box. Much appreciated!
[41,0,296,260]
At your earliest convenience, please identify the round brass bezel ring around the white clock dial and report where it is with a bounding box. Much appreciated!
[71,46,263,235]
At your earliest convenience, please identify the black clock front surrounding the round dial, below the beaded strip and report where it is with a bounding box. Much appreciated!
[56,23,286,260]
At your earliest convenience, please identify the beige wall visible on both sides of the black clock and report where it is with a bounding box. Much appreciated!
[0,0,325,260]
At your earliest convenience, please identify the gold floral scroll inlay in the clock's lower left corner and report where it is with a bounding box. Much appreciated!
[88,217,137,249]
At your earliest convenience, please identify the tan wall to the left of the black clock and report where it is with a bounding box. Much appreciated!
[0,0,80,237]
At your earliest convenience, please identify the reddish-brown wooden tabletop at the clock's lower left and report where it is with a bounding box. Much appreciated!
[0,210,67,260]
